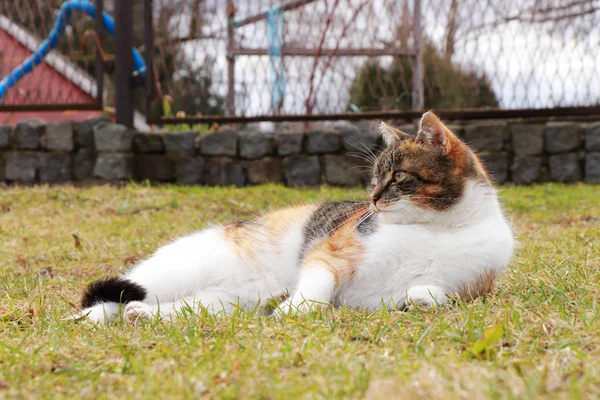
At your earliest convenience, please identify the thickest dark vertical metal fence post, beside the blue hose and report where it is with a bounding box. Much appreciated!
[115,0,133,128]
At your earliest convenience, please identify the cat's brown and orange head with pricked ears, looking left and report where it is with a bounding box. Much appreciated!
[371,111,489,219]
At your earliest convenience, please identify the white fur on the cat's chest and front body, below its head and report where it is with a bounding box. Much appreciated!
[335,182,513,308]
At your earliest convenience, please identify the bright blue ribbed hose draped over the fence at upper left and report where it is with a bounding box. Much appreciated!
[0,0,146,99]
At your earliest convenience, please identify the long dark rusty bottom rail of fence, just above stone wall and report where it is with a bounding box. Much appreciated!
[152,106,600,124]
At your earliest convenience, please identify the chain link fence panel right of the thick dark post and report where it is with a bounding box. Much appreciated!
[149,0,600,122]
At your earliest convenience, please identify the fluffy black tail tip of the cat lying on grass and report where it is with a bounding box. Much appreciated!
[81,277,146,308]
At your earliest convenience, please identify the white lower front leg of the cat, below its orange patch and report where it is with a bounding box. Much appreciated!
[276,265,336,316]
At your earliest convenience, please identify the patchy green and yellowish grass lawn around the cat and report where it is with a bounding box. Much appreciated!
[0,185,600,399]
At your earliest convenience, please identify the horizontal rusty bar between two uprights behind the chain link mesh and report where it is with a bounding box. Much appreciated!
[231,46,415,57]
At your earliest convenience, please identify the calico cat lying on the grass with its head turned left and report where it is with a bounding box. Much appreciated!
[81,112,513,323]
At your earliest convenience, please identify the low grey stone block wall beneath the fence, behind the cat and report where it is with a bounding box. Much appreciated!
[0,119,600,186]
